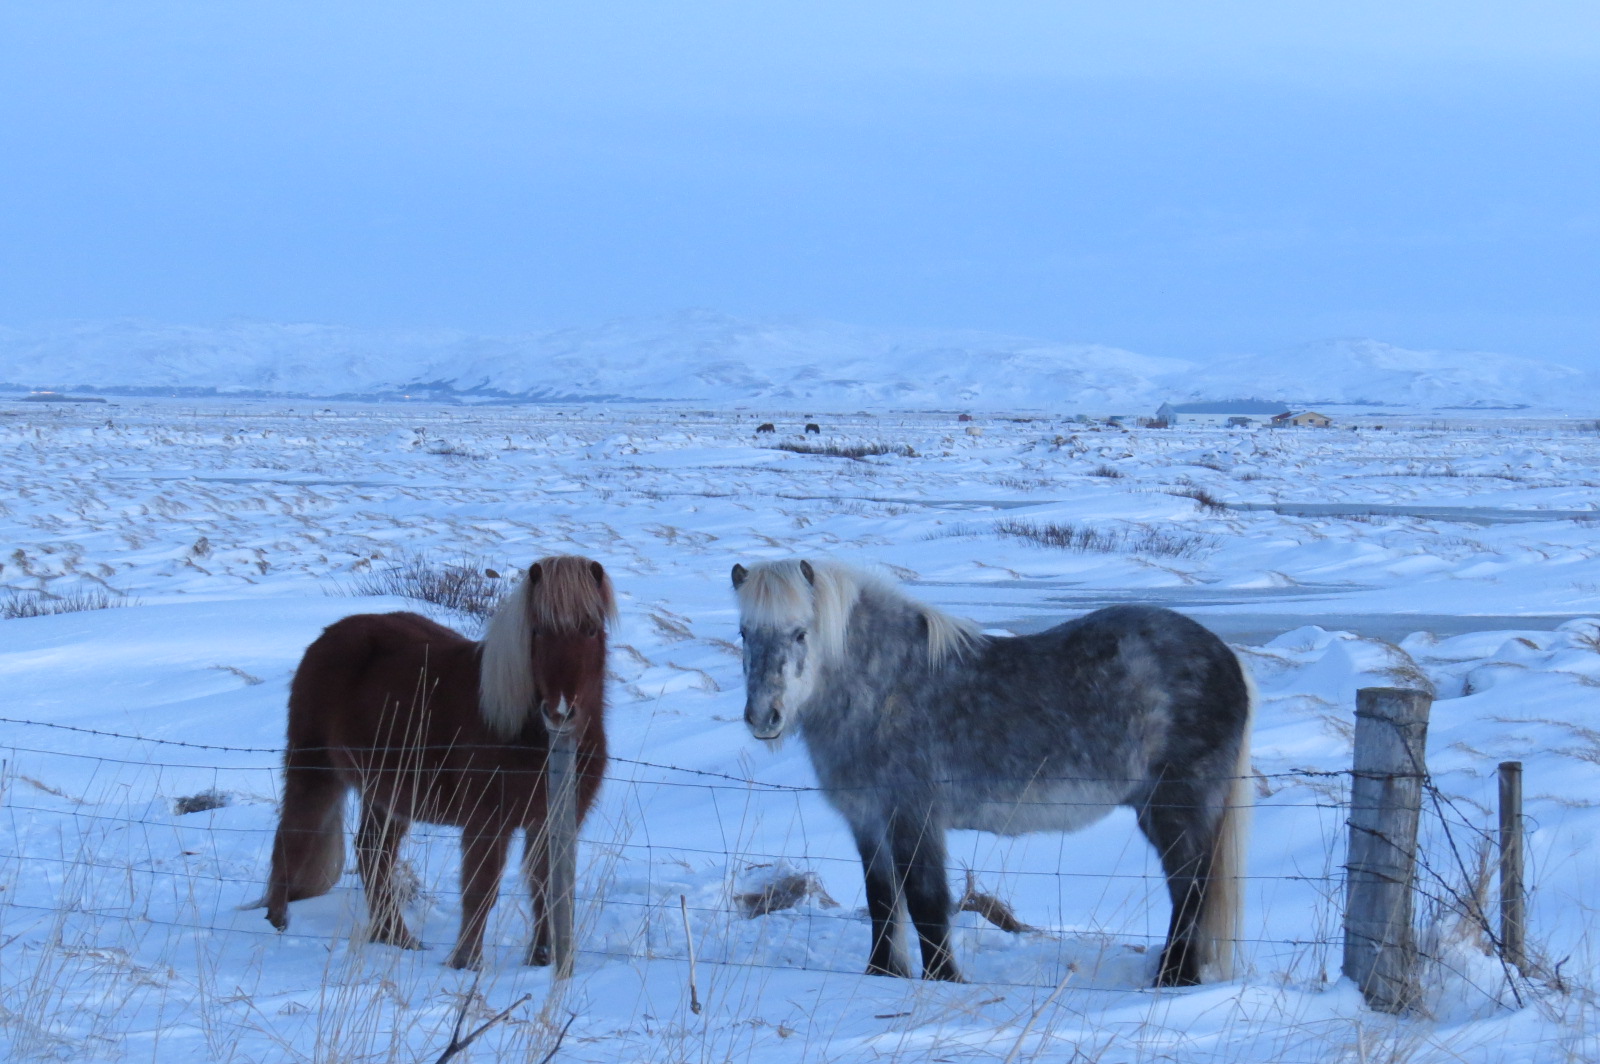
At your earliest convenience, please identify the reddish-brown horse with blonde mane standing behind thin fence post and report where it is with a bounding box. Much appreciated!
[264,557,616,968]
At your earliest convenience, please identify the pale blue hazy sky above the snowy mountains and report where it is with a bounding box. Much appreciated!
[0,0,1600,365]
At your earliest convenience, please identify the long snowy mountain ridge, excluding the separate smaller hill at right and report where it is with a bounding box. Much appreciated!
[0,312,1192,408]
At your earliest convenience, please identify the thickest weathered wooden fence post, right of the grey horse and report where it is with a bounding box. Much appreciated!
[1344,686,1432,1013]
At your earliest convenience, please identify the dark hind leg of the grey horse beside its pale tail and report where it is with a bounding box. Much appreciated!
[1139,782,1218,986]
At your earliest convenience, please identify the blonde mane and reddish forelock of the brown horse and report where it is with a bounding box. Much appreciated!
[478,554,616,738]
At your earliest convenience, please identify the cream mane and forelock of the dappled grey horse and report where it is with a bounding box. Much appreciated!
[734,558,979,666]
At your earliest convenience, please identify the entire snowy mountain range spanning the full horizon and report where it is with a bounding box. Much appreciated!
[0,310,1600,411]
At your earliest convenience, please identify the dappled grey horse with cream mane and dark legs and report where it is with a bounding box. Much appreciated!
[733,562,1251,986]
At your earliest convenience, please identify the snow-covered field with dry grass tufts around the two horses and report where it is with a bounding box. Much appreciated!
[0,400,1600,1064]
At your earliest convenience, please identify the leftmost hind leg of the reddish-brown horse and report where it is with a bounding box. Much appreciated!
[266,749,347,931]
